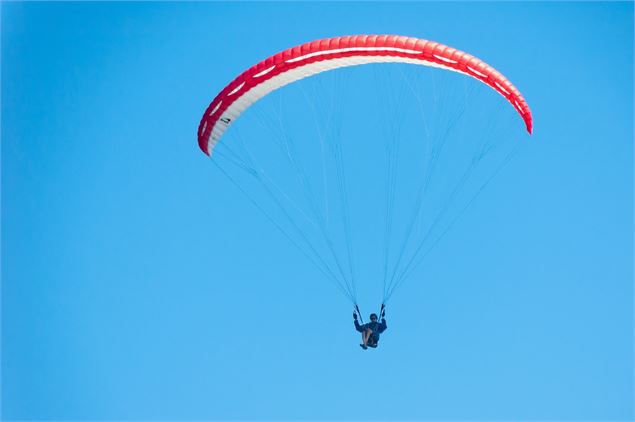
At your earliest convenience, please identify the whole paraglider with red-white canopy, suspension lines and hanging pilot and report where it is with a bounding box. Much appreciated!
[198,35,533,348]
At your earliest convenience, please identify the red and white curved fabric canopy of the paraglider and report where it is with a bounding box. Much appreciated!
[198,35,533,155]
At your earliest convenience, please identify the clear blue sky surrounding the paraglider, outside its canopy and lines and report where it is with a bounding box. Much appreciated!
[1,2,634,421]
